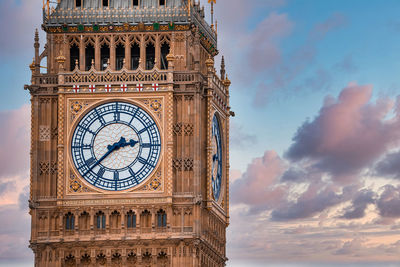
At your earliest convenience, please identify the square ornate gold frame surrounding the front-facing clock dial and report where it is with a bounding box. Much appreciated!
[64,95,166,195]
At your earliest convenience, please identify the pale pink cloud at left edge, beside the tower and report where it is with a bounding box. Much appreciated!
[0,105,30,179]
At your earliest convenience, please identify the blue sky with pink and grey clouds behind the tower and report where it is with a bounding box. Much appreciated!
[0,0,400,267]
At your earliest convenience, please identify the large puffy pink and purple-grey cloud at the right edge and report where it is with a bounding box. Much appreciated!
[285,84,400,179]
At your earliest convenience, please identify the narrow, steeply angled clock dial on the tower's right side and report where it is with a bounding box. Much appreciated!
[211,115,222,200]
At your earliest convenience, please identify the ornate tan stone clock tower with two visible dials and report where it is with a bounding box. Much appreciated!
[25,0,232,267]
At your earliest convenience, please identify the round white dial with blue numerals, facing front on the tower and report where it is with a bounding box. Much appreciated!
[71,102,161,191]
